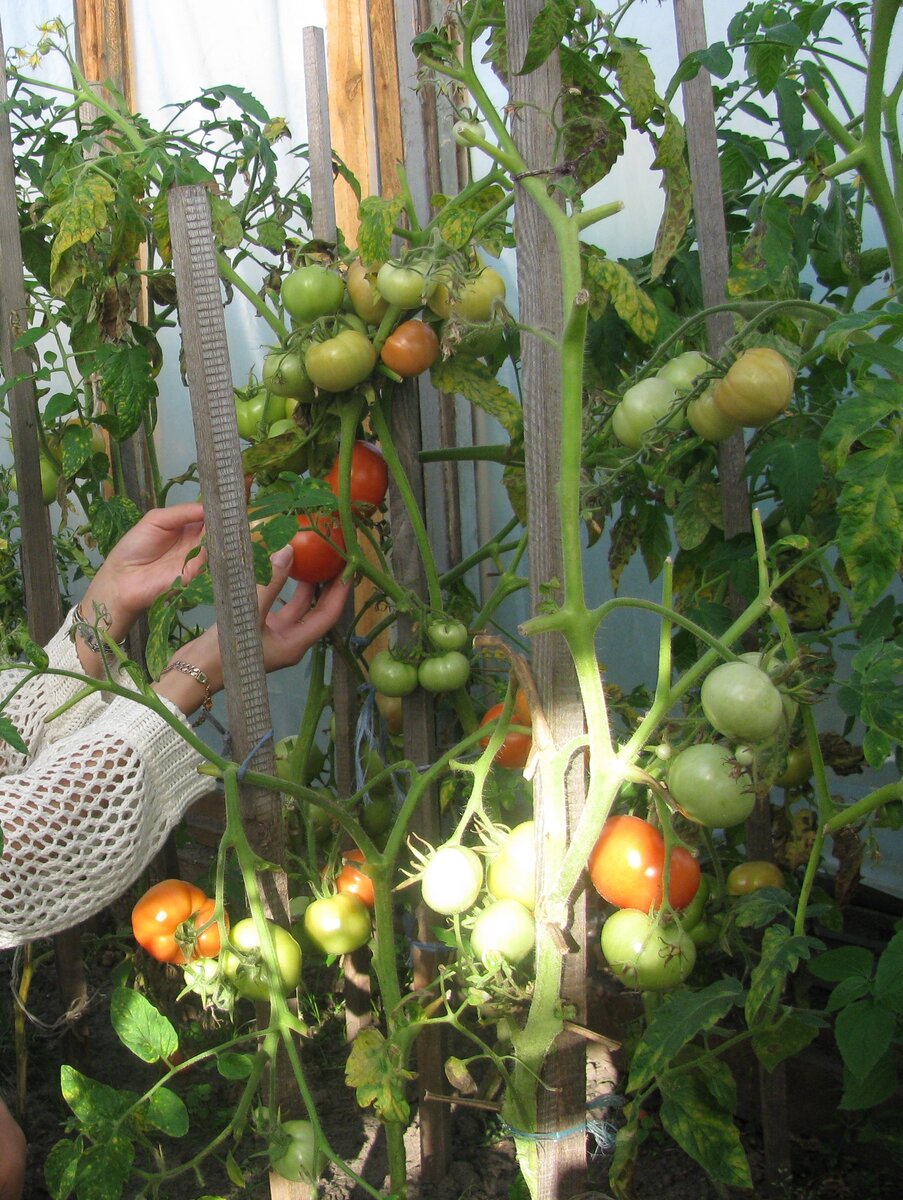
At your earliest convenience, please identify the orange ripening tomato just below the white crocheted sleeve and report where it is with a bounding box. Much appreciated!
[132,880,228,962]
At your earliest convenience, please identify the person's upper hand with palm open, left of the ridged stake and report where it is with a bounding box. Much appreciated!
[82,503,207,642]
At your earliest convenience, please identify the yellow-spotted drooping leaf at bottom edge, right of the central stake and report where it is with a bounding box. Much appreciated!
[659,1063,753,1188]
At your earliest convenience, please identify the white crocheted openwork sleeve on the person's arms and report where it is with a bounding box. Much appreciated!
[0,616,210,949]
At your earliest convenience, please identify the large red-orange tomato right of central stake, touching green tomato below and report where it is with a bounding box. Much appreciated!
[588,816,701,912]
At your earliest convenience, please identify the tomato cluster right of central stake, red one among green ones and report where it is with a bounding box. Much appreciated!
[587,654,796,991]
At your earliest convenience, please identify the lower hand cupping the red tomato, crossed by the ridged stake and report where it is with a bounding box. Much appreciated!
[155,546,352,714]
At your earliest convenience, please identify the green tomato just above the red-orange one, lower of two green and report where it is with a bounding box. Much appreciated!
[668,743,755,829]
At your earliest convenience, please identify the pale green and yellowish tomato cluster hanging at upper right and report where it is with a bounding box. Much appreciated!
[611,346,795,450]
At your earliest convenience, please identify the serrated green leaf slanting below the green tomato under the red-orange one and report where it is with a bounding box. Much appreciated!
[627,979,743,1092]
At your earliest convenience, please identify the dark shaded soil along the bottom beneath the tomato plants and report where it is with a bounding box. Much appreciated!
[0,926,901,1200]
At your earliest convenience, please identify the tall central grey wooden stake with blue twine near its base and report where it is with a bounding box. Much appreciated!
[506,0,586,1200]
